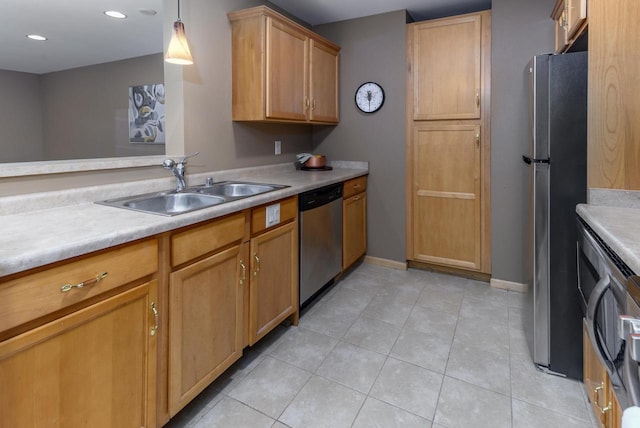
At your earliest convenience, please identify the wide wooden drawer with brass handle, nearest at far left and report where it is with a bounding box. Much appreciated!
[0,239,158,332]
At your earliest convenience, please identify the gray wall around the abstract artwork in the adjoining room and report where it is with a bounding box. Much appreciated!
[41,54,164,160]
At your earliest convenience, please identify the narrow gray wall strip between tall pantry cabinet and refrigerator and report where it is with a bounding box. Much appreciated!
[491,0,555,283]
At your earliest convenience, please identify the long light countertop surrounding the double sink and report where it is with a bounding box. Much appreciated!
[0,162,368,277]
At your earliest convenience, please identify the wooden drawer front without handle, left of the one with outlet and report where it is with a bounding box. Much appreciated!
[171,212,246,266]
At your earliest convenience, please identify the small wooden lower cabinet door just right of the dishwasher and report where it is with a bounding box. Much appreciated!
[342,193,367,270]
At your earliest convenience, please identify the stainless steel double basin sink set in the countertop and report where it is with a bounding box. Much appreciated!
[96,181,289,216]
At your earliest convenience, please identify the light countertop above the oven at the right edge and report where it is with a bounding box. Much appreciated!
[576,204,640,275]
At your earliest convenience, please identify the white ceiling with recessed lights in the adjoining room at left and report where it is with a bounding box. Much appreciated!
[0,0,163,74]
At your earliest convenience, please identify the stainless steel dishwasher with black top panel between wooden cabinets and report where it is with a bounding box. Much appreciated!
[298,183,342,308]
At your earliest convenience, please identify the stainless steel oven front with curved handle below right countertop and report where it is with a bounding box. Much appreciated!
[577,218,633,404]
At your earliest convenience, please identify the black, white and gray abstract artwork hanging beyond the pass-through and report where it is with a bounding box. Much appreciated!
[129,83,165,144]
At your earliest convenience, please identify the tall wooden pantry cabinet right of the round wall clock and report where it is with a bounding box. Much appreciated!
[407,11,491,274]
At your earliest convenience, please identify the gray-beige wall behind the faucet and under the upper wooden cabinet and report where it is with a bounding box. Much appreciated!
[167,0,313,172]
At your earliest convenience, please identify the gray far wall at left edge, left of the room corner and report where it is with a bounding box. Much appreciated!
[0,70,43,162]
